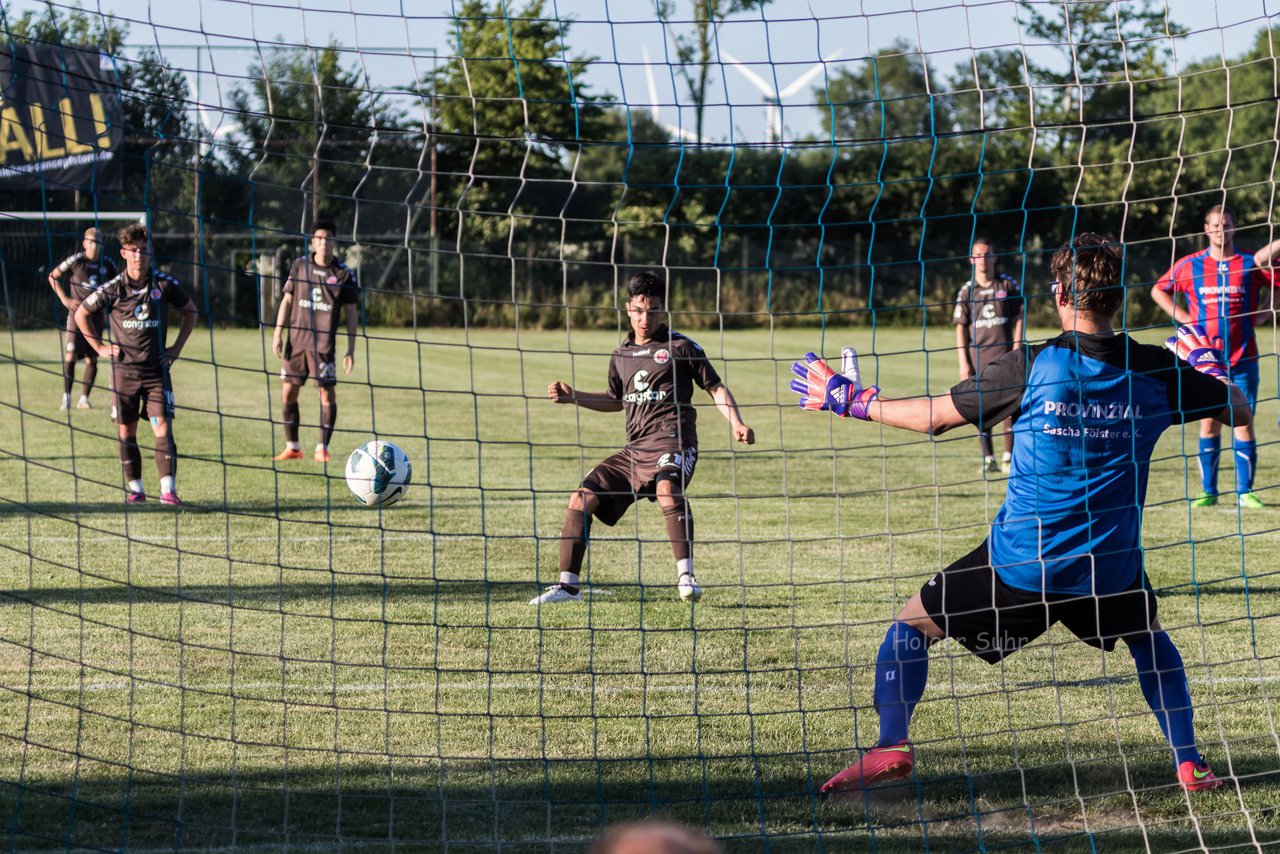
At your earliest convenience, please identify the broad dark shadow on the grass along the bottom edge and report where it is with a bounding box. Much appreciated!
[0,739,1280,851]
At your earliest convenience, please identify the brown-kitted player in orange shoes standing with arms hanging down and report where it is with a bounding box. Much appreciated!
[271,220,360,462]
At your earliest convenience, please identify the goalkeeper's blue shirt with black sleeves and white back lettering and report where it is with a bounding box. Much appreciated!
[951,332,1230,595]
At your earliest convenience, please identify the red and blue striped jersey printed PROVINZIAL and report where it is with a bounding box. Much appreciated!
[1156,250,1275,365]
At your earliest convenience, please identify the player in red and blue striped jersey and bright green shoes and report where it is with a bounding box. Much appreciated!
[1151,205,1280,508]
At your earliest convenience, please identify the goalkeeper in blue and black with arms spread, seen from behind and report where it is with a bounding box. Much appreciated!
[791,234,1251,793]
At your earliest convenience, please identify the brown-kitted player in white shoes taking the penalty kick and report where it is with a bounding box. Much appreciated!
[529,273,755,606]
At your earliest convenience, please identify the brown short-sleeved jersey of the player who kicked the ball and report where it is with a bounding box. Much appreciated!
[609,326,721,451]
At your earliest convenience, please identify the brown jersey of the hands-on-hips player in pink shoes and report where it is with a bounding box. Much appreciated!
[84,273,191,371]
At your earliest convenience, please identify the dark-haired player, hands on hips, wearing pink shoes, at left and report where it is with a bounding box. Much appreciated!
[76,223,196,504]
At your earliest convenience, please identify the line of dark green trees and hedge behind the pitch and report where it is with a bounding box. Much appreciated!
[3,0,1277,325]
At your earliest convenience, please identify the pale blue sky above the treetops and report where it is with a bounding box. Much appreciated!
[8,0,1280,142]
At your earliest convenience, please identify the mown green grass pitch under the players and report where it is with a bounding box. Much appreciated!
[0,328,1280,851]
